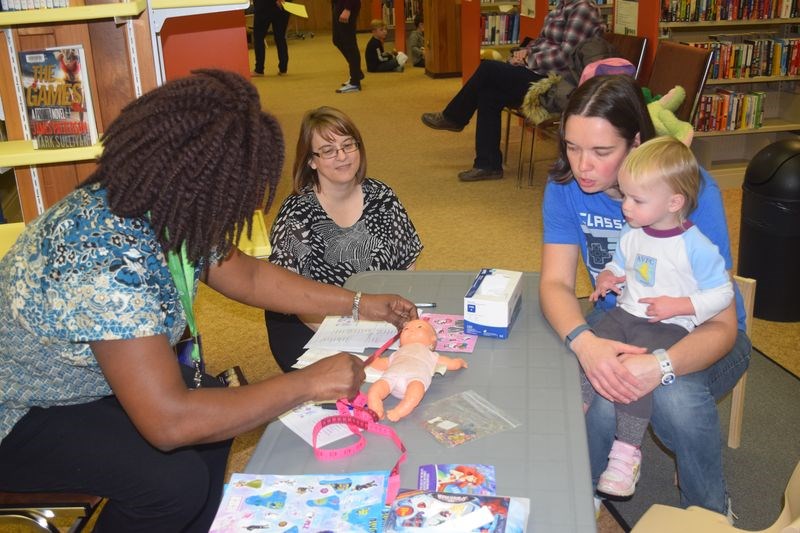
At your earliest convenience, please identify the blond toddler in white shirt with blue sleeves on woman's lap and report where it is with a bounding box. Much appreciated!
[581,137,733,497]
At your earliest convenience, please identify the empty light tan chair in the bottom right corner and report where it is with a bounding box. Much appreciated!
[631,463,800,533]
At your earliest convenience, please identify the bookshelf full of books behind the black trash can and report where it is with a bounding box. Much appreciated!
[658,12,800,187]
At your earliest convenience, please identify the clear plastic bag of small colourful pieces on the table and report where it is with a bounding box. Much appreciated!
[422,390,520,448]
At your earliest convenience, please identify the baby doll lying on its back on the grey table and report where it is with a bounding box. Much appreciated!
[367,320,467,422]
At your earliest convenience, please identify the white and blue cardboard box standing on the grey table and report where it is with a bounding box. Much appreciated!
[464,268,522,339]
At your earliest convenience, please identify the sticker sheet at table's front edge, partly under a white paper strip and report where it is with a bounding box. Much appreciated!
[384,490,511,533]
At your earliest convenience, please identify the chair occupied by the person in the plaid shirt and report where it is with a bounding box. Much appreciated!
[503,33,647,186]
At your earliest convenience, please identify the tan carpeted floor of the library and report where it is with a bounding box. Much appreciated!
[197,34,800,533]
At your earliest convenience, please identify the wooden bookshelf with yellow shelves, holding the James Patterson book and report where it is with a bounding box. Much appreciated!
[0,0,248,222]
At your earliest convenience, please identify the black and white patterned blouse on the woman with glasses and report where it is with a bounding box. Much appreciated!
[269,178,422,286]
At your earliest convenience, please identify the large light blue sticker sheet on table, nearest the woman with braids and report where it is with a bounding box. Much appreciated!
[210,472,389,533]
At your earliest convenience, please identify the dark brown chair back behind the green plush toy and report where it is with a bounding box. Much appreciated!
[644,40,711,122]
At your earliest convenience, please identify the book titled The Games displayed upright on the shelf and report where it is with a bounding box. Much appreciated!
[19,45,98,149]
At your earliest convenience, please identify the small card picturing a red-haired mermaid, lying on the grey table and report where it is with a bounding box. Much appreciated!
[417,463,497,496]
